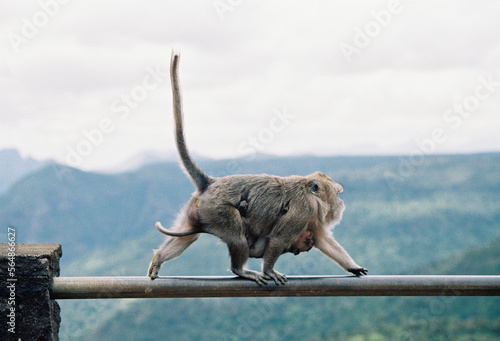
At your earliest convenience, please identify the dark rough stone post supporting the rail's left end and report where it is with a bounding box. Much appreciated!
[0,242,62,341]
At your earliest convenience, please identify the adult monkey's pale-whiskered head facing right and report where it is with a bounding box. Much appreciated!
[306,172,345,225]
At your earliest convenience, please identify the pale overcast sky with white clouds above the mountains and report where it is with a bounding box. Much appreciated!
[0,0,500,170]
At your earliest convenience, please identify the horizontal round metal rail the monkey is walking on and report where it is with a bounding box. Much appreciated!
[51,275,500,299]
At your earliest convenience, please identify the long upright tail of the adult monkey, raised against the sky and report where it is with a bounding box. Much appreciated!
[170,51,213,192]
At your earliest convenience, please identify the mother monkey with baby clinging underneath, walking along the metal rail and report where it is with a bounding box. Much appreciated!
[148,52,368,285]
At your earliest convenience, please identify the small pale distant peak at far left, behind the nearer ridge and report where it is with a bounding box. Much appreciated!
[0,149,48,194]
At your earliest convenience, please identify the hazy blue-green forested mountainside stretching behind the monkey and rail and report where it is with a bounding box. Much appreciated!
[0,153,492,340]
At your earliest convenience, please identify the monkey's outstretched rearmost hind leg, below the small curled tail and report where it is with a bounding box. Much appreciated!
[148,219,199,279]
